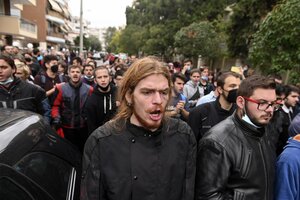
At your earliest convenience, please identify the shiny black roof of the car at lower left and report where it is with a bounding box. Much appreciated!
[0,108,81,166]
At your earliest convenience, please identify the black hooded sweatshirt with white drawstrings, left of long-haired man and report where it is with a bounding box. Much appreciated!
[85,85,117,133]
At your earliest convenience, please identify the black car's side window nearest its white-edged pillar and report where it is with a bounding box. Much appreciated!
[14,152,73,199]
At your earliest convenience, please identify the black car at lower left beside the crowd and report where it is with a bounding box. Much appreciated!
[0,109,81,200]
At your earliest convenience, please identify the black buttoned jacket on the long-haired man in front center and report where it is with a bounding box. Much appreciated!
[81,118,196,200]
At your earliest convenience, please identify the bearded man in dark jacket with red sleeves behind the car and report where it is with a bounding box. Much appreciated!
[51,65,93,152]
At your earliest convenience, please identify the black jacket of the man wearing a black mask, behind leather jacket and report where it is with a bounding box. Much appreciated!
[188,98,236,142]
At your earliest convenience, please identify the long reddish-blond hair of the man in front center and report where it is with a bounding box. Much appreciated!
[115,57,172,120]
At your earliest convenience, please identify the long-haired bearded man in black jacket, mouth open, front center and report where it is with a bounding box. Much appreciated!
[81,57,196,200]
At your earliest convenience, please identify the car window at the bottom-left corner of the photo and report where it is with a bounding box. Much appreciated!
[0,178,33,200]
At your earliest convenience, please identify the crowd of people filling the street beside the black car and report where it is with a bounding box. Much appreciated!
[0,45,300,200]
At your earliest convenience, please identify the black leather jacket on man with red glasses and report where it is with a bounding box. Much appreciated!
[196,114,276,200]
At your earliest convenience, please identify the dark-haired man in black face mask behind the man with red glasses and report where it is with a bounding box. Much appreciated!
[188,72,241,142]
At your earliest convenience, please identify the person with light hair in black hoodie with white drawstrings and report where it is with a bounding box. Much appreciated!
[85,67,117,133]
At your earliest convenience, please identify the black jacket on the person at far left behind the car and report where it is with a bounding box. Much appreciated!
[0,78,48,115]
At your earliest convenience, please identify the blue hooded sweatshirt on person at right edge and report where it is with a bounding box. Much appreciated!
[275,134,300,200]
